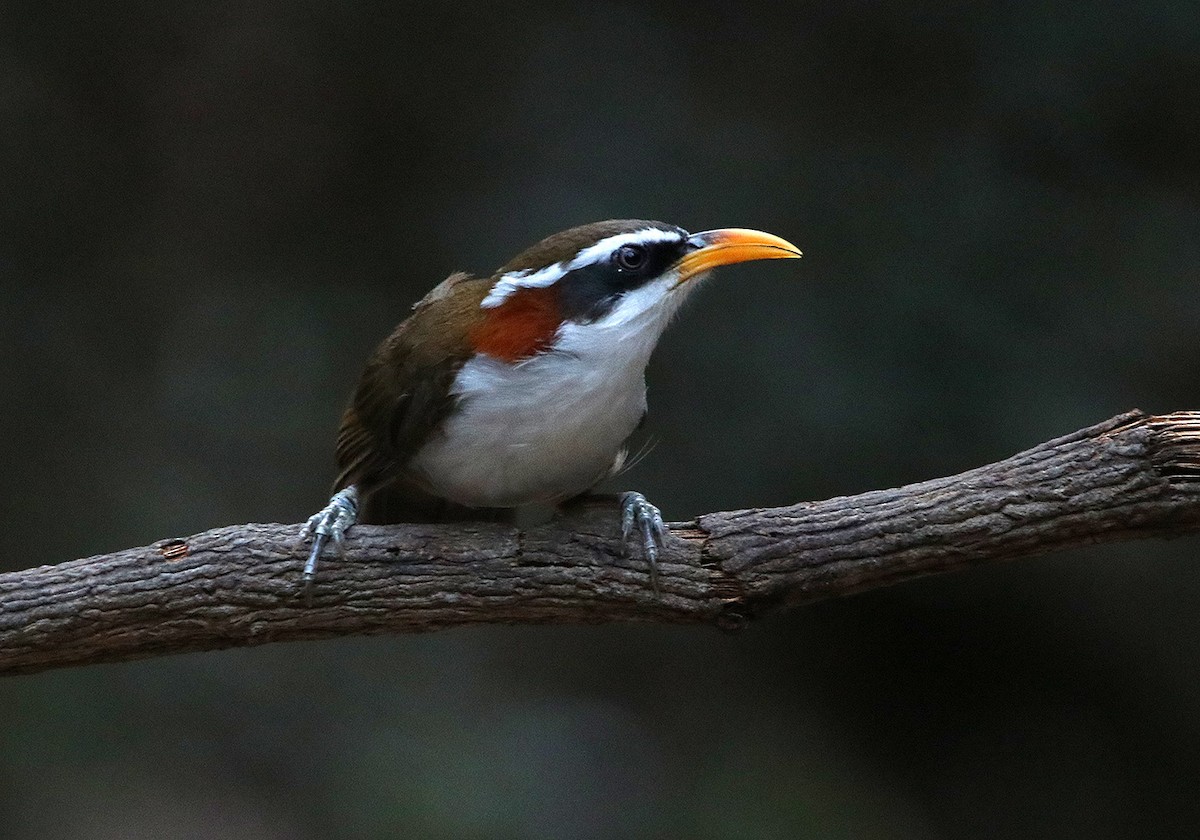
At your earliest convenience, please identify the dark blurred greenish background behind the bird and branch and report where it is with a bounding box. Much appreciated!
[0,0,1200,840]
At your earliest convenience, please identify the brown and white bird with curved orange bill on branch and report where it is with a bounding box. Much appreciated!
[302,220,800,593]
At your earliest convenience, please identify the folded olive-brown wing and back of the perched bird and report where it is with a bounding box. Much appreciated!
[334,274,488,494]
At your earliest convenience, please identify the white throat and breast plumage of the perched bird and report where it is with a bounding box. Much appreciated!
[409,277,683,508]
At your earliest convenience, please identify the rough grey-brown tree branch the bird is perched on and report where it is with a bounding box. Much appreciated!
[0,412,1200,673]
